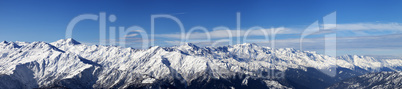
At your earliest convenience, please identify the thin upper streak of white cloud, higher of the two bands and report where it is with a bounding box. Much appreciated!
[156,23,402,39]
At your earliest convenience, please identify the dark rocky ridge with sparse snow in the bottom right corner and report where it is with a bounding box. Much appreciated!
[329,72,402,89]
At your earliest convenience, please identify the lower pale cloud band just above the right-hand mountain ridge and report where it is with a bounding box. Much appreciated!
[257,34,402,50]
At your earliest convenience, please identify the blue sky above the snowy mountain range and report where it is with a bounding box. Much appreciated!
[0,0,402,56]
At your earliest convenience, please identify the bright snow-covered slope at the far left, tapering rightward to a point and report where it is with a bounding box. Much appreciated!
[0,42,91,88]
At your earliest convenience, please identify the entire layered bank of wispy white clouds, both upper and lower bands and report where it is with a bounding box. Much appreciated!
[133,23,402,55]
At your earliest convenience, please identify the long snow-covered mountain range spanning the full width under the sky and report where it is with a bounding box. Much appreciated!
[0,39,402,89]
